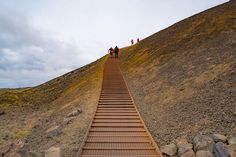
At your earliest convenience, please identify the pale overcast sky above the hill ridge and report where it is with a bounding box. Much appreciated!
[0,0,227,88]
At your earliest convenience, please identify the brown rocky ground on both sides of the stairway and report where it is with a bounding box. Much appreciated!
[0,1,236,157]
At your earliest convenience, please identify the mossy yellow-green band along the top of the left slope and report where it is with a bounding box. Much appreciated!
[0,58,107,109]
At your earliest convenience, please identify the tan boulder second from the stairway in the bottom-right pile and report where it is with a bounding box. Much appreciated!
[177,139,194,156]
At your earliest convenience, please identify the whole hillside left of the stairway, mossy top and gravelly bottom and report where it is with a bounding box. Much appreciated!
[0,57,106,157]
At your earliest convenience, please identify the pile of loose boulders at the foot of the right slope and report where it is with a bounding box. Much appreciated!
[160,134,236,157]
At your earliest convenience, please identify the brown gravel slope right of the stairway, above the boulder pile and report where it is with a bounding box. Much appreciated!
[120,2,236,145]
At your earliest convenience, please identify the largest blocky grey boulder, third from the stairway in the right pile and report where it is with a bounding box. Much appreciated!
[193,135,214,153]
